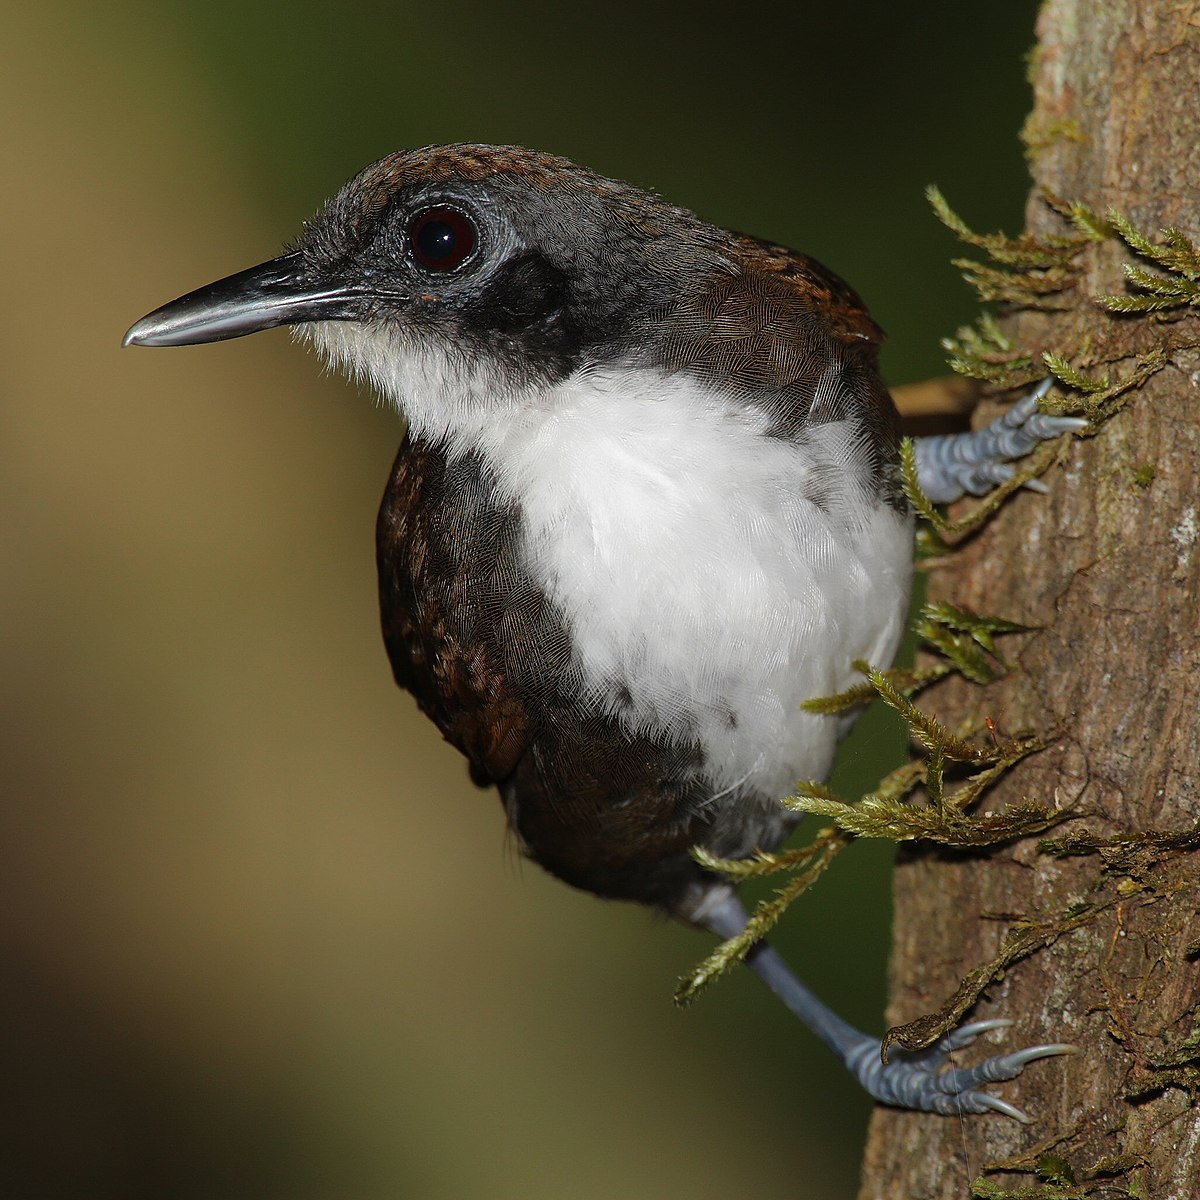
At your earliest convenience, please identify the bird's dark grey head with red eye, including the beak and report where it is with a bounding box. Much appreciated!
[125,145,732,403]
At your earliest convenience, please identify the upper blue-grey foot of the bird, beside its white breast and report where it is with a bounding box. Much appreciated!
[913,379,1088,504]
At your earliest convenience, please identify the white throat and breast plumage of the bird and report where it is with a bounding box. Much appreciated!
[307,324,912,796]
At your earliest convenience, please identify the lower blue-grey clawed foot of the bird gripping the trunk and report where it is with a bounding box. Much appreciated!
[845,1020,1075,1124]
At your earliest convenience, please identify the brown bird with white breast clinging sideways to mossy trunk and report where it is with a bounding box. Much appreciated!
[125,144,1080,1120]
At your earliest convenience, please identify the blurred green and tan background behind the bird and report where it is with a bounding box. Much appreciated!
[0,0,1036,1200]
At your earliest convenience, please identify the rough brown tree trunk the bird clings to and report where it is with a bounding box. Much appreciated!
[860,0,1200,1200]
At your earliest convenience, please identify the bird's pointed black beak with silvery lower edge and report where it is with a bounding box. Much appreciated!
[121,253,365,346]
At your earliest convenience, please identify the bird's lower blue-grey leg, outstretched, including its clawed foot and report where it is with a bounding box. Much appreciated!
[703,895,1075,1123]
